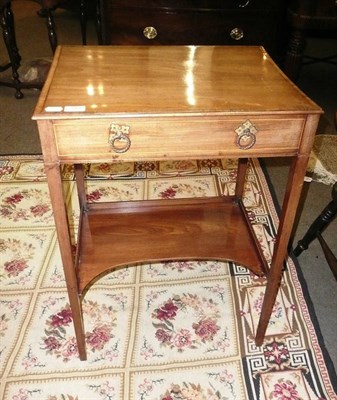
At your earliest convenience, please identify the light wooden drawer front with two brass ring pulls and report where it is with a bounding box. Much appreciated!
[53,116,304,162]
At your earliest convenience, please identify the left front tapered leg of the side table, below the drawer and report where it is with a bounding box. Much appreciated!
[45,164,87,360]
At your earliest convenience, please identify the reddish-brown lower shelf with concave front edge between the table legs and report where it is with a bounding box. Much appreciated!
[76,197,267,293]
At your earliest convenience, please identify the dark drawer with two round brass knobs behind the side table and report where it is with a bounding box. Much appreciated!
[103,8,280,50]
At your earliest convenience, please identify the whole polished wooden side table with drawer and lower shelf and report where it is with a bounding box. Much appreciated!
[33,46,322,360]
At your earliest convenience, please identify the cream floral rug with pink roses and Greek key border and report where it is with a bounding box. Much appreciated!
[0,156,337,400]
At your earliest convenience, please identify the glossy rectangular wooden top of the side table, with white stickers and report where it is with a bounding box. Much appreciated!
[33,46,320,119]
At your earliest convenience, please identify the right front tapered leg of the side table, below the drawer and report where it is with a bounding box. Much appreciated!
[255,155,308,346]
